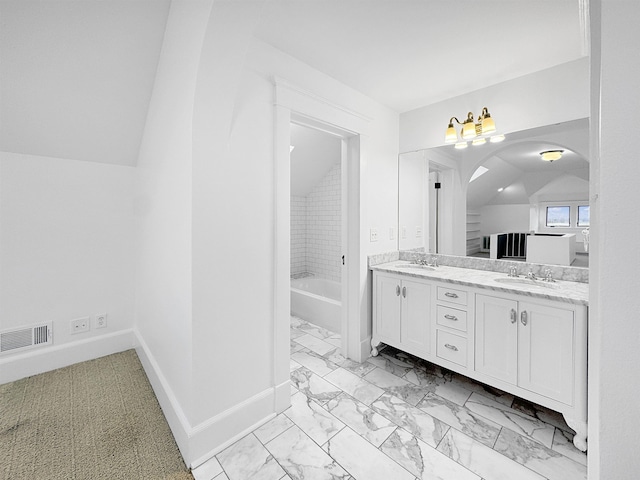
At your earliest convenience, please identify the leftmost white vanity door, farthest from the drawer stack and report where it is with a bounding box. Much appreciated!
[375,274,401,346]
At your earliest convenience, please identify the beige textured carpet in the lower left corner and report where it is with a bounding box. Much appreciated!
[0,350,193,480]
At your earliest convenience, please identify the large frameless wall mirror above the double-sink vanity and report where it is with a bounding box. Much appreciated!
[398,119,589,267]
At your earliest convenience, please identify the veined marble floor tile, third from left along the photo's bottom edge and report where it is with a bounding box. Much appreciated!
[265,426,350,480]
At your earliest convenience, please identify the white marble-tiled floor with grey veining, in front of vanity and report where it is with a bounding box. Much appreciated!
[193,317,587,480]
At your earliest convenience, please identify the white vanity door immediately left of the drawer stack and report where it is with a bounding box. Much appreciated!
[400,280,431,356]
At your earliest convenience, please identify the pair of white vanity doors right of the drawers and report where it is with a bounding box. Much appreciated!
[475,294,576,405]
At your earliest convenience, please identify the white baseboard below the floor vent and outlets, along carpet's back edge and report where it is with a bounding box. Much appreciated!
[0,329,136,384]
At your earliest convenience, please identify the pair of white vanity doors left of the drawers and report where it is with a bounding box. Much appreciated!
[371,272,432,357]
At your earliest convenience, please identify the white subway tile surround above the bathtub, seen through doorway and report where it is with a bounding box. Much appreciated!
[291,163,342,282]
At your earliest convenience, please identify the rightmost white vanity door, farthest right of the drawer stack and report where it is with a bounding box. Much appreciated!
[518,302,575,405]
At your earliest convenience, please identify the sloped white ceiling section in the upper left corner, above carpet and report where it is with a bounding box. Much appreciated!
[0,0,170,165]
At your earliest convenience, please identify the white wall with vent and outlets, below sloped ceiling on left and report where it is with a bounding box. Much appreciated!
[0,152,134,382]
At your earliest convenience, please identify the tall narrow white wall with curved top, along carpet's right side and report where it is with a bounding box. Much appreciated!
[135,1,215,463]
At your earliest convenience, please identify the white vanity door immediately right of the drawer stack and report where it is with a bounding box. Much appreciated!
[475,295,518,385]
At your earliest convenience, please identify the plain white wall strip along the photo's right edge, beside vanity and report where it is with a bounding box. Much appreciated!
[588,0,640,480]
